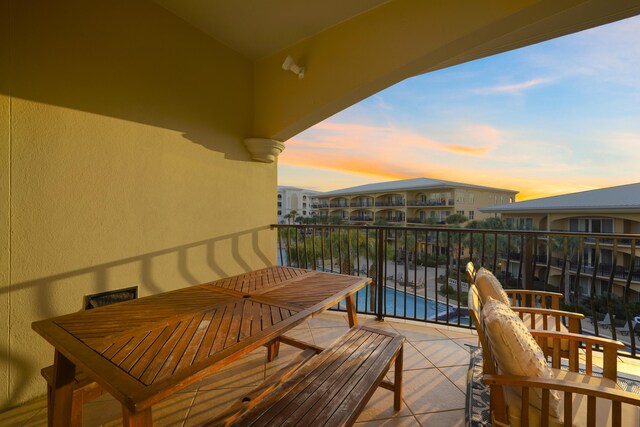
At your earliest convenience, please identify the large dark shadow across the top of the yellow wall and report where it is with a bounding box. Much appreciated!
[6,0,252,161]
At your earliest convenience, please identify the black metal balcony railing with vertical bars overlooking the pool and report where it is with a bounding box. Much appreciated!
[273,225,640,357]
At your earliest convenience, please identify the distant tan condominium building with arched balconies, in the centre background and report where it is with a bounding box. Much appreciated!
[318,178,518,225]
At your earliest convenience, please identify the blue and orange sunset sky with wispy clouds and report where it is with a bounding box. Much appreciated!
[278,17,640,200]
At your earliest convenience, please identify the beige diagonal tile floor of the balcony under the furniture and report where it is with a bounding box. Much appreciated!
[0,312,640,427]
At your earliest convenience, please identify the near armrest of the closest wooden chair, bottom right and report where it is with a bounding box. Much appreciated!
[483,374,640,406]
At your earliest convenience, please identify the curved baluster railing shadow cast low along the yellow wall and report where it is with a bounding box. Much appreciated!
[0,226,273,407]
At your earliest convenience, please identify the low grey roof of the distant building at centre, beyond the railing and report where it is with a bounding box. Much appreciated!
[320,178,518,197]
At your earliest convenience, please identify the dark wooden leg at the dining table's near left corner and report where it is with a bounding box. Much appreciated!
[47,350,76,427]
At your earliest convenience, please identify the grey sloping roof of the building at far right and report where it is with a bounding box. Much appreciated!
[480,183,640,213]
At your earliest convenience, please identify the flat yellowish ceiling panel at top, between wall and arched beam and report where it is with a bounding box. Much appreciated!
[155,0,389,59]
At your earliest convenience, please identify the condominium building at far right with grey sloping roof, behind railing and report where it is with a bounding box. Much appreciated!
[481,183,640,301]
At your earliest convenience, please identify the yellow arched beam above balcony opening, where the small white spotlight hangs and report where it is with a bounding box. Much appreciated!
[139,0,640,141]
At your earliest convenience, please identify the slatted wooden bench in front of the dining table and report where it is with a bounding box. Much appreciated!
[207,326,404,426]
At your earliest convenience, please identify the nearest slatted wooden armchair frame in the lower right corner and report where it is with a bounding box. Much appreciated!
[469,289,640,427]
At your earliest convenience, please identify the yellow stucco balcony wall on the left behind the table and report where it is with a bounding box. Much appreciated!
[0,0,276,410]
